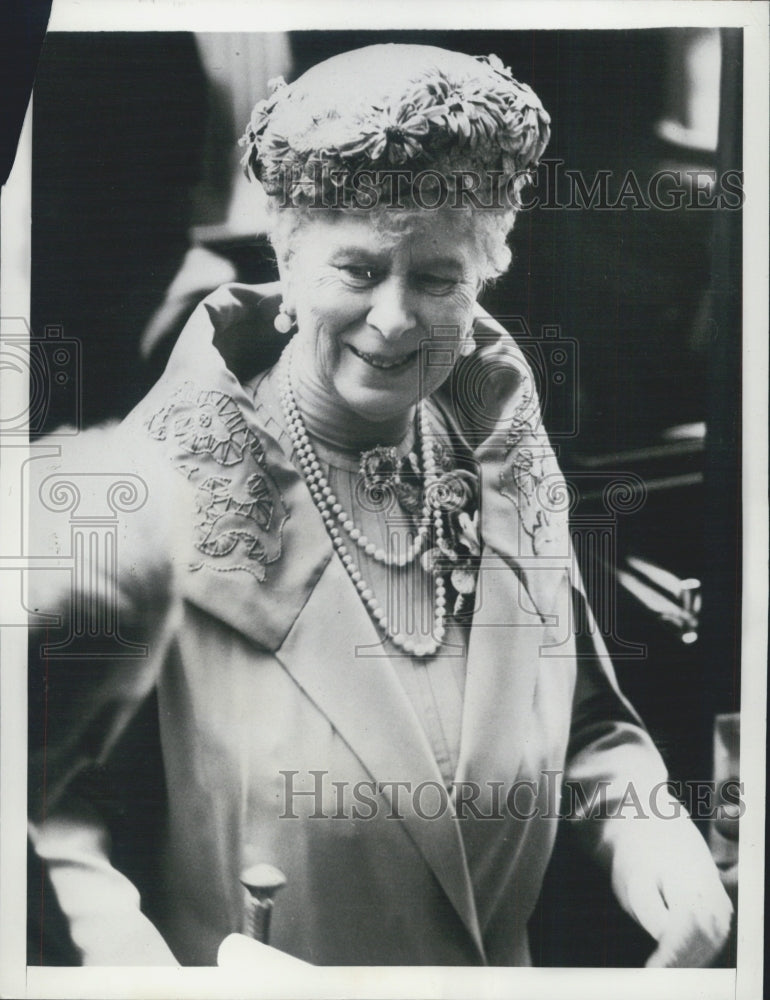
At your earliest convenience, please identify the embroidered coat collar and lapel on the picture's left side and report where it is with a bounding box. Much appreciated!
[128,286,332,649]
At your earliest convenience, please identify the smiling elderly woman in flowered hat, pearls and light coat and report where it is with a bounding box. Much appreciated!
[30,45,731,965]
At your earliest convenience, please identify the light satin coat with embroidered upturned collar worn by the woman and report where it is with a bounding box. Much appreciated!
[31,286,666,965]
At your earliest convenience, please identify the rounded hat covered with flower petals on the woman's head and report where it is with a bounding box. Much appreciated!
[240,44,550,208]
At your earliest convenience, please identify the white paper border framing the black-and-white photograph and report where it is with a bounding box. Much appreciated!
[0,0,770,1000]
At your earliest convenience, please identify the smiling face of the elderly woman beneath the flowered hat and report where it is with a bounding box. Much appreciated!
[282,211,479,423]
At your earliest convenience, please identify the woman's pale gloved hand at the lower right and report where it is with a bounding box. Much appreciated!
[607,818,733,968]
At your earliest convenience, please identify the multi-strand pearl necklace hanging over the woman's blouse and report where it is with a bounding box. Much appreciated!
[279,340,446,656]
